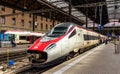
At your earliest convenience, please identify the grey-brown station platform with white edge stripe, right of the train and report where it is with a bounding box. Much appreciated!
[42,43,120,74]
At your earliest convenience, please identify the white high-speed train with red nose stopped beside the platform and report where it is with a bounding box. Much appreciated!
[27,22,107,63]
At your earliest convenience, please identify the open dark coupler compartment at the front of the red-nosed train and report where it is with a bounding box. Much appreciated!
[27,50,47,63]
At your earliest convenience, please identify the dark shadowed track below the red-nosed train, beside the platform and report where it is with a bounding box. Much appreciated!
[16,58,64,74]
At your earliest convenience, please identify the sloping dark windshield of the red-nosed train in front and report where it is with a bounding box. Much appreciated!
[47,26,68,37]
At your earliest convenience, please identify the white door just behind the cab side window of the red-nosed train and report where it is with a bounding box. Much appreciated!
[75,29,84,48]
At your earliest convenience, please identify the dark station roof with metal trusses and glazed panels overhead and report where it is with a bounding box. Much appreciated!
[0,0,120,25]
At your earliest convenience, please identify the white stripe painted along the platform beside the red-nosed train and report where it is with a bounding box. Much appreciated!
[53,47,103,74]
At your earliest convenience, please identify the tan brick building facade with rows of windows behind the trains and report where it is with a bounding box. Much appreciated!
[0,5,60,32]
